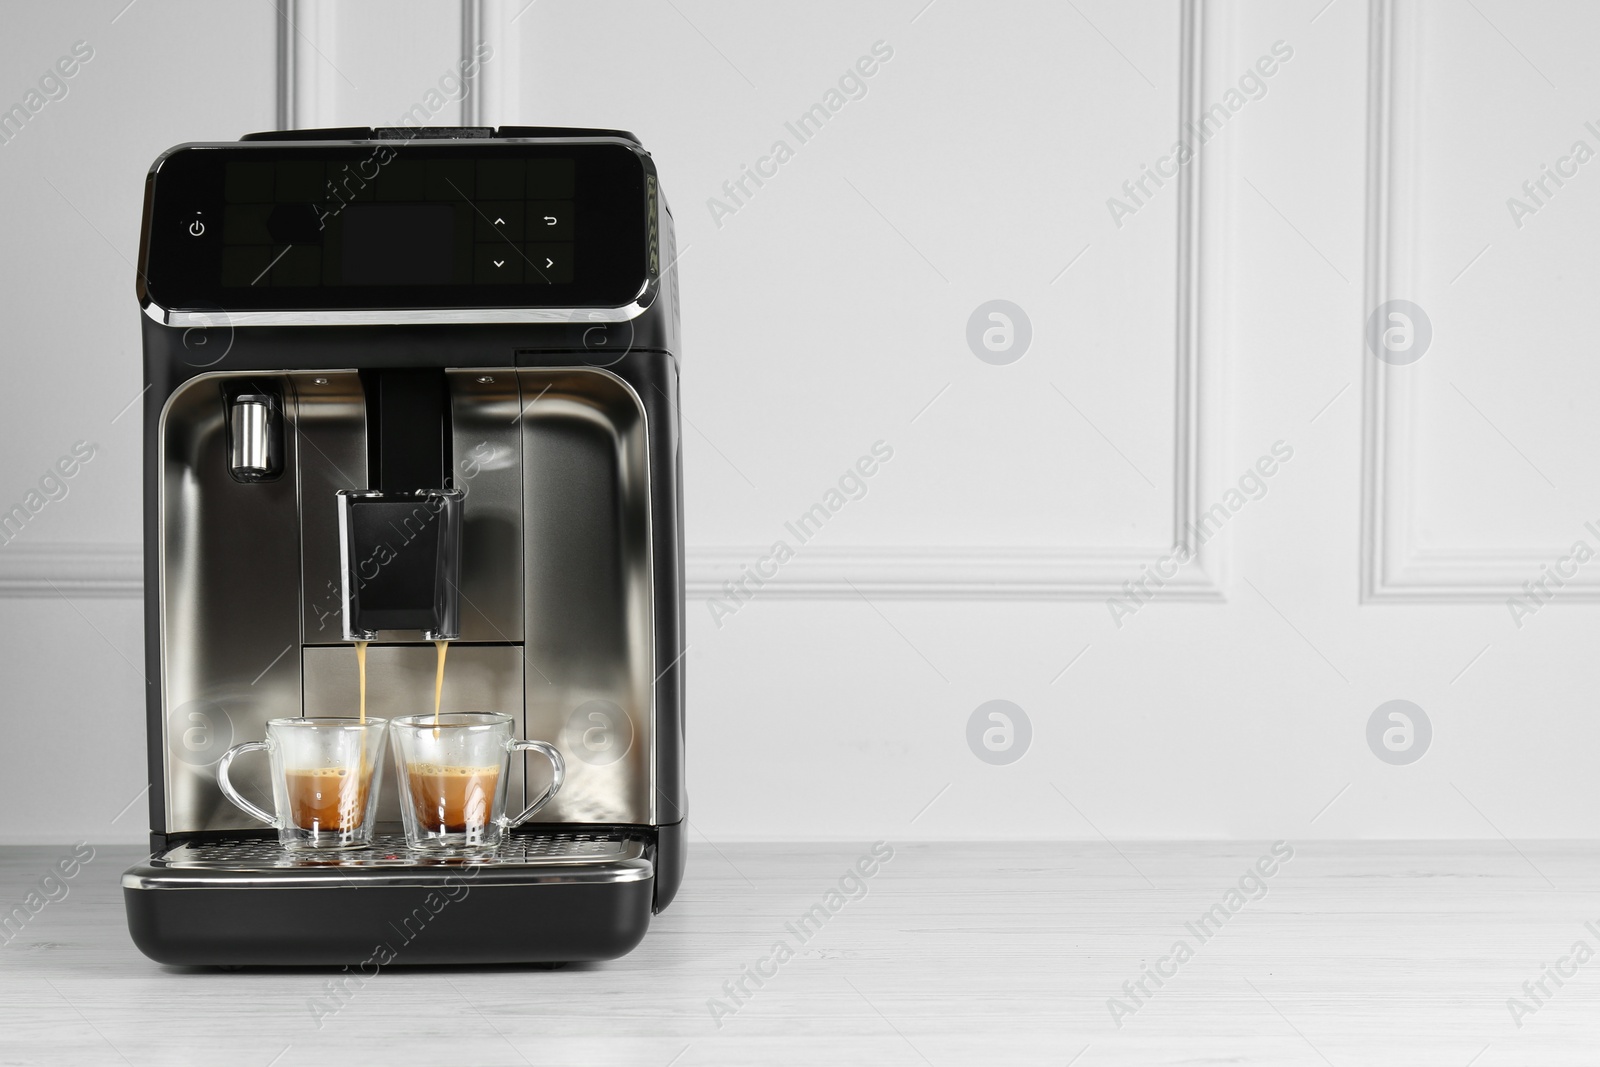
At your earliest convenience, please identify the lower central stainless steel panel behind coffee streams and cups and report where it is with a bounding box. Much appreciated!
[304,641,524,822]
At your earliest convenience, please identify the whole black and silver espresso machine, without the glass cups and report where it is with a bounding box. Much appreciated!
[123,126,686,969]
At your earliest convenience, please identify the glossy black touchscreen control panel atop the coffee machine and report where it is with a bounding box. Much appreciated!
[141,141,656,310]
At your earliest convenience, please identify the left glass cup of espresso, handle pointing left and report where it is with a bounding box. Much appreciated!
[216,717,389,851]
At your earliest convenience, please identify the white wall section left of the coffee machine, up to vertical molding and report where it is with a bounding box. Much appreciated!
[0,0,275,841]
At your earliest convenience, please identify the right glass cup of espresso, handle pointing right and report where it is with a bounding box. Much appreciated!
[390,712,566,856]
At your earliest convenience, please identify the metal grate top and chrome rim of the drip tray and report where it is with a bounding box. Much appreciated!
[123,832,653,889]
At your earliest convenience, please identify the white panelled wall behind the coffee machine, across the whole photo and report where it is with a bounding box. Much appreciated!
[0,0,1600,844]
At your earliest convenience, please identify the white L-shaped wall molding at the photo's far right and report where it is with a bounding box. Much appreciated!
[1360,0,1600,603]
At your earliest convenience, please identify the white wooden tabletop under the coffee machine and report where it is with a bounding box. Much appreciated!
[0,843,1600,1067]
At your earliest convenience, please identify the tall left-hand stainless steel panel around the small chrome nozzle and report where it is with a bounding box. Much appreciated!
[158,374,301,832]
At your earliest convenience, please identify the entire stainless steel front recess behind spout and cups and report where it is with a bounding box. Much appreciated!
[160,368,661,833]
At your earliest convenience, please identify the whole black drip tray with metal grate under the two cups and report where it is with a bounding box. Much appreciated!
[122,827,656,973]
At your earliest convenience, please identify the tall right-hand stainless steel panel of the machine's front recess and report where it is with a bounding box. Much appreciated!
[518,370,656,824]
